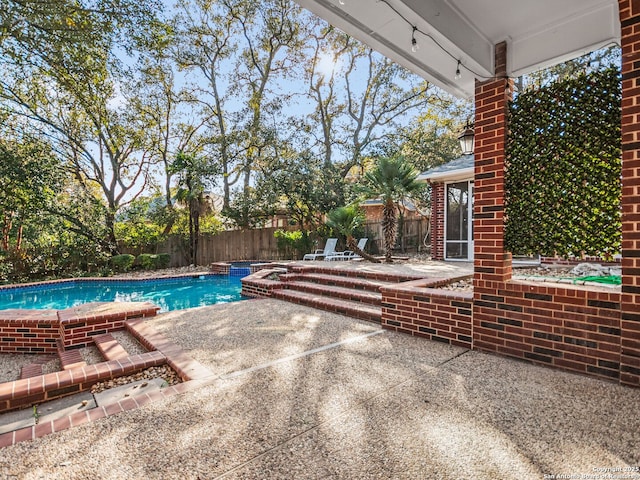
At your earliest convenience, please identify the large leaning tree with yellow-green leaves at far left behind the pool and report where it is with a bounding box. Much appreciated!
[0,0,162,252]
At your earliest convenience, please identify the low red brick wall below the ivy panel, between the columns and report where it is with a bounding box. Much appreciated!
[473,281,620,379]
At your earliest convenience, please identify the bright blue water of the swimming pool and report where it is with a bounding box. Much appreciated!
[0,275,243,312]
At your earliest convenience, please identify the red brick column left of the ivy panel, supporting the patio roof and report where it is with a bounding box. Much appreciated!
[473,42,513,289]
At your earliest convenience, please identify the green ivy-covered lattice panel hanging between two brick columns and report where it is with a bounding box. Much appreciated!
[505,68,622,257]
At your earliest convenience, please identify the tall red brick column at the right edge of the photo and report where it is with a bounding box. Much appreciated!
[618,0,640,386]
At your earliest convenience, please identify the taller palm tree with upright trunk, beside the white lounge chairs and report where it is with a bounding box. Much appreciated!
[360,156,425,263]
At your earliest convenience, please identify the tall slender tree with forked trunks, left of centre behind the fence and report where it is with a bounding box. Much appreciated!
[178,0,301,226]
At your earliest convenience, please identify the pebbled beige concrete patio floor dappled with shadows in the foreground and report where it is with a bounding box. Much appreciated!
[0,290,640,479]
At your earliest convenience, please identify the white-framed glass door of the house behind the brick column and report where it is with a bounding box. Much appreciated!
[445,181,473,260]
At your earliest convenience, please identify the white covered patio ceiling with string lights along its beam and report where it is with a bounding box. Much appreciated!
[296,0,620,97]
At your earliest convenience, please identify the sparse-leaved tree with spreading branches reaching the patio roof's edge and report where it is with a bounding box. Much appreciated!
[305,22,438,178]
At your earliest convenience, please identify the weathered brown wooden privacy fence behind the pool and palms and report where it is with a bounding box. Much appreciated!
[142,219,429,267]
